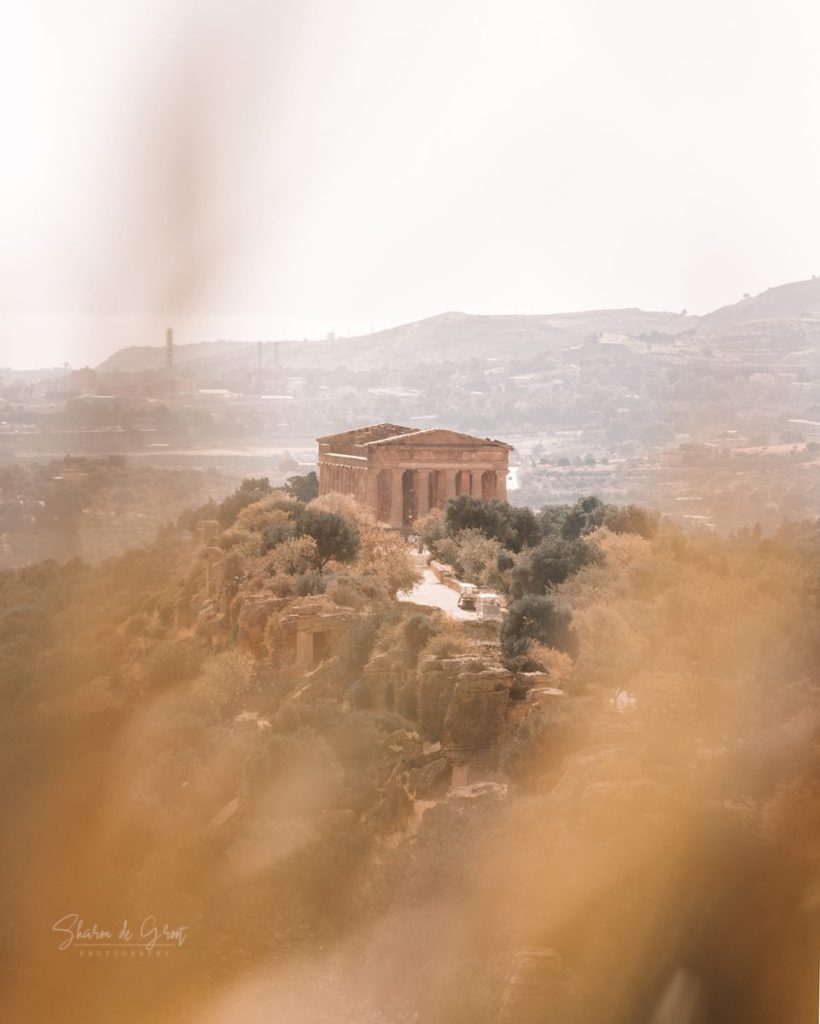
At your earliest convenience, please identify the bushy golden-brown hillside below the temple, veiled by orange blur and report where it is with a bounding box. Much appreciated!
[0,480,820,1024]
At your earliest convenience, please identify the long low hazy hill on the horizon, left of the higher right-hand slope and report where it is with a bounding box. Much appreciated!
[98,309,697,376]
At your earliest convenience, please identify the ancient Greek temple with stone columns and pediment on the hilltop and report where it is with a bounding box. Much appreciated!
[318,423,511,530]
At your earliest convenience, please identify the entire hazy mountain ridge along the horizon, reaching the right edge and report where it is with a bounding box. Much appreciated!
[97,278,820,377]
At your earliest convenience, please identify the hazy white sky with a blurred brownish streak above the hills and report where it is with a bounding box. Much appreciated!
[0,0,820,367]
